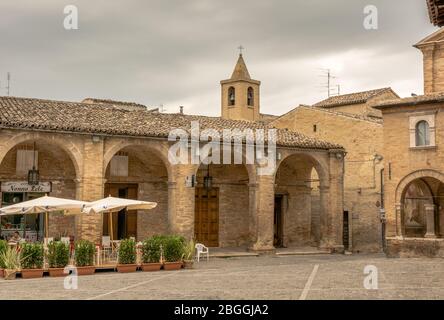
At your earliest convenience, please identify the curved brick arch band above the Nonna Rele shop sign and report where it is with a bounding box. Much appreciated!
[0,132,83,179]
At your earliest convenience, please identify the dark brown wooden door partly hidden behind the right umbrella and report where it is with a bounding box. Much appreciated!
[103,183,137,240]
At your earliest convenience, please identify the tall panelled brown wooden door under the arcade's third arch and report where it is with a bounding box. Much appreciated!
[194,188,219,247]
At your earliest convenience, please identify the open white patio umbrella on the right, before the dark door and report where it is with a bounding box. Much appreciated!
[83,196,157,240]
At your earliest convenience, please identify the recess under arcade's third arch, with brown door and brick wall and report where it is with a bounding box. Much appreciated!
[193,159,254,247]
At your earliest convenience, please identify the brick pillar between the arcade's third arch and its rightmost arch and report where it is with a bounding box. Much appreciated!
[252,175,274,251]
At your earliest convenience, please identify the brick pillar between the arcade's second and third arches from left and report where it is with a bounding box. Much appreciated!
[168,165,196,239]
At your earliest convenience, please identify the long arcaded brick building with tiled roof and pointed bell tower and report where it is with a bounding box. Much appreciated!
[0,56,345,252]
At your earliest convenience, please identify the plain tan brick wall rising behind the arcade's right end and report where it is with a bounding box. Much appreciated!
[272,105,383,252]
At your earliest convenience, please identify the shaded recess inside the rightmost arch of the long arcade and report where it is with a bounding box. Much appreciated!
[274,150,330,247]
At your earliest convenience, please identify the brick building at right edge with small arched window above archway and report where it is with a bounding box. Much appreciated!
[375,29,444,257]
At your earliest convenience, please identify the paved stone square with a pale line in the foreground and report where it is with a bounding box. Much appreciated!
[0,255,444,300]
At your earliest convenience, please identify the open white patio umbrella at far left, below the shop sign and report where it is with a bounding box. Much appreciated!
[0,196,89,238]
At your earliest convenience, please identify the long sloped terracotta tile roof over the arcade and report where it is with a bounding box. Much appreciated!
[0,97,342,150]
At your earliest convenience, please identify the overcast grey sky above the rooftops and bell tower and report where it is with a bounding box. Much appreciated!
[0,0,436,115]
